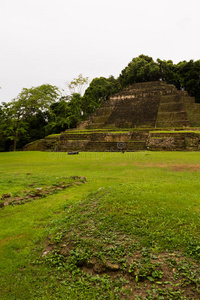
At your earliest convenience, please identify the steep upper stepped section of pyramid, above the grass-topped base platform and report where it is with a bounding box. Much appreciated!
[78,81,200,129]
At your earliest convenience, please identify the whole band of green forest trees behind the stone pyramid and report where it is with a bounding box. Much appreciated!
[0,55,200,151]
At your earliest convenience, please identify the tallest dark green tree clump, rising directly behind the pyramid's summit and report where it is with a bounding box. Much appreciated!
[118,55,200,102]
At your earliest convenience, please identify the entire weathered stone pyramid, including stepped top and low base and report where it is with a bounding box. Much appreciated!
[24,81,200,152]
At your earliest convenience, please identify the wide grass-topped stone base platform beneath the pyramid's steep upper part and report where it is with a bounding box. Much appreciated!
[24,130,200,152]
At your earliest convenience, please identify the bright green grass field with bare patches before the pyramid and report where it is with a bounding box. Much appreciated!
[0,152,200,300]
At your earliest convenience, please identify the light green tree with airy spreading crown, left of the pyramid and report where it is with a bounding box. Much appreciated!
[4,84,60,151]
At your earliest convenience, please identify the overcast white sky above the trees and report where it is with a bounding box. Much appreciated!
[0,0,200,102]
